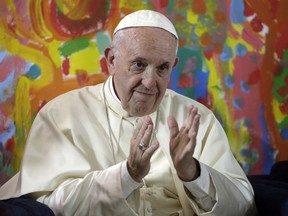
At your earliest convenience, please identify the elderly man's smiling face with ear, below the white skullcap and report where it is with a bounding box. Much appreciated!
[105,27,178,116]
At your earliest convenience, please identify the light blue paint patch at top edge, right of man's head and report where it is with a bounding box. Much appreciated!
[230,0,246,24]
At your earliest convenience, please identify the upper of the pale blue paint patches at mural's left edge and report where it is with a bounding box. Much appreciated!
[0,70,15,103]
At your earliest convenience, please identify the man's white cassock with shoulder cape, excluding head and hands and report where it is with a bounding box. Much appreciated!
[0,77,255,216]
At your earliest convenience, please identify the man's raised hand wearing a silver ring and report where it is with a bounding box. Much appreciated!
[127,116,159,182]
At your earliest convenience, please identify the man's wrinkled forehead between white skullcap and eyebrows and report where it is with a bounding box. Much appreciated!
[116,27,177,60]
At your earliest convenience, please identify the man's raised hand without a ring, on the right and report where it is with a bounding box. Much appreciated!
[167,105,200,181]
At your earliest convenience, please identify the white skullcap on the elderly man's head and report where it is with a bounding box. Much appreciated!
[113,10,178,39]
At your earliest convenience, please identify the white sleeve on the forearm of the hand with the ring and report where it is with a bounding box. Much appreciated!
[37,163,137,216]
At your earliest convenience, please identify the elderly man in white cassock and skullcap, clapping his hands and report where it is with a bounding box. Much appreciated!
[0,10,254,216]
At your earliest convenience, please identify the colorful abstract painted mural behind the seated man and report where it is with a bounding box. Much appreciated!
[0,0,288,182]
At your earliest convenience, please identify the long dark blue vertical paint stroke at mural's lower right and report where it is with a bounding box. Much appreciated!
[259,106,275,174]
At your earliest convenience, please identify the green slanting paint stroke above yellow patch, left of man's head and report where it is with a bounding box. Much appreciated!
[58,37,90,57]
